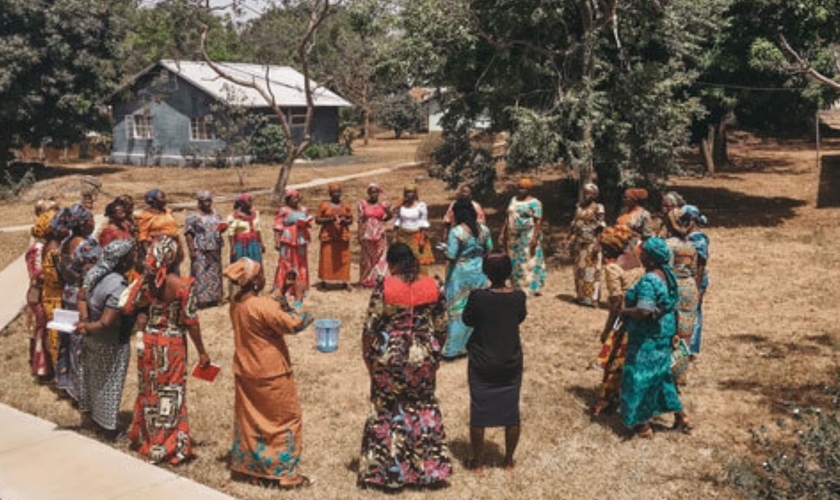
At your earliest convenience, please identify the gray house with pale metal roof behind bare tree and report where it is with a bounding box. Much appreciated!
[110,60,351,165]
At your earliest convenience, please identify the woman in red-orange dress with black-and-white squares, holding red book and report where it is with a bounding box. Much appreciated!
[121,236,210,465]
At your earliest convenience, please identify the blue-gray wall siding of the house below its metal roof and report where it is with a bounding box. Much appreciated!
[111,67,339,165]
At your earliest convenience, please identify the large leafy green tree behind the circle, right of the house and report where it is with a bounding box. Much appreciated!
[403,0,729,203]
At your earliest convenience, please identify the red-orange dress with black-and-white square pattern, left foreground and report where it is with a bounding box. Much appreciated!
[123,278,198,465]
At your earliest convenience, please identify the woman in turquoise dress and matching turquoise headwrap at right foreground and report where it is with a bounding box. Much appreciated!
[620,238,691,438]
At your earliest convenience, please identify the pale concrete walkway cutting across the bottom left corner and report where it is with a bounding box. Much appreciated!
[0,404,233,500]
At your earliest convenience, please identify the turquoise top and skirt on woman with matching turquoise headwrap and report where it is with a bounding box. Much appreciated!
[619,273,682,427]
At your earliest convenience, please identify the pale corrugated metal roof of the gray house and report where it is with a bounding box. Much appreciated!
[160,60,352,108]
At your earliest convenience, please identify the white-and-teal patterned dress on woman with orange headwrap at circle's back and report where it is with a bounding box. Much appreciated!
[507,197,545,293]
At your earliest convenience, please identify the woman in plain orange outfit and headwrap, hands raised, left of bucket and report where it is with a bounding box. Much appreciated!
[224,258,309,488]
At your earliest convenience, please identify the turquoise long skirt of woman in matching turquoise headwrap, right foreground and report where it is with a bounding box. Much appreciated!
[619,338,682,427]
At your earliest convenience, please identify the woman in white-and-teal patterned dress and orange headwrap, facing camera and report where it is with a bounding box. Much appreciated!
[500,179,545,296]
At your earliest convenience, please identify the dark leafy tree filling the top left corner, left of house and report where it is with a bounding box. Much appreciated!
[0,0,130,170]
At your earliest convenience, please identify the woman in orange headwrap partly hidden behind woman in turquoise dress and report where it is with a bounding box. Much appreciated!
[592,226,645,415]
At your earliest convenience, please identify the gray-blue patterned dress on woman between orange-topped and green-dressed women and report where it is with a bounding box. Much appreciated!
[184,210,224,305]
